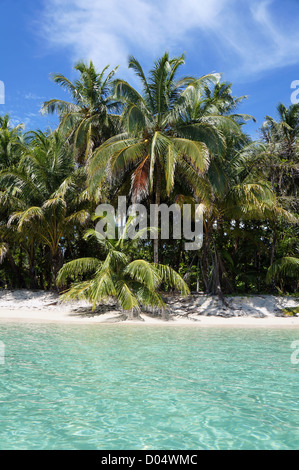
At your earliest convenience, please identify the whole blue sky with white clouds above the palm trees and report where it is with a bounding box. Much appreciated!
[0,0,299,137]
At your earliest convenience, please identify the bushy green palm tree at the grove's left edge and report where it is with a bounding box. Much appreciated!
[0,131,89,285]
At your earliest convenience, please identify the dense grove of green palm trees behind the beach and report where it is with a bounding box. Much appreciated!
[0,53,299,304]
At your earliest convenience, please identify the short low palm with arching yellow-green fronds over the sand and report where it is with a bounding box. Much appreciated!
[57,220,189,319]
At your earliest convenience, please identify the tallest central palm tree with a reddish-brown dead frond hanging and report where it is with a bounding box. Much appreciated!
[89,53,224,263]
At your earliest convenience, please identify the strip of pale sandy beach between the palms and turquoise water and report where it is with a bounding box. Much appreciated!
[0,290,299,328]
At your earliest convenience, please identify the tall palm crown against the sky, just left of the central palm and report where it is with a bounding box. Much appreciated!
[42,61,119,164]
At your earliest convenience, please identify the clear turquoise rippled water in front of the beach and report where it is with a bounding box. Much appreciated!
[0,324,299,450]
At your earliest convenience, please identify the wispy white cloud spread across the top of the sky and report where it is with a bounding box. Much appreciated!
[42,0,299,79]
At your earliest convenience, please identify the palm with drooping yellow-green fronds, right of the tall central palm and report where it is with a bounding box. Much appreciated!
[196,138,294,298]
